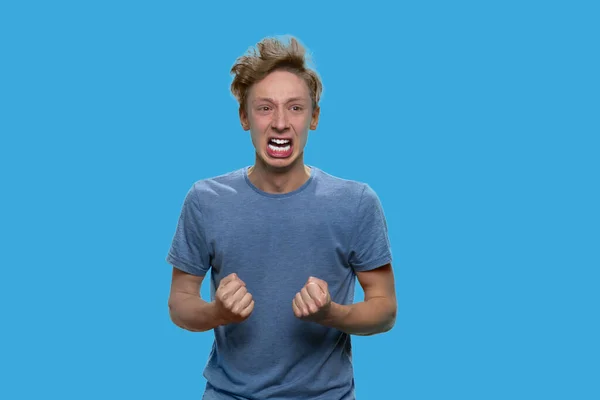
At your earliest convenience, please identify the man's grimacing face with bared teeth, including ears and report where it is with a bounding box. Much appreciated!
[240,71,320,169]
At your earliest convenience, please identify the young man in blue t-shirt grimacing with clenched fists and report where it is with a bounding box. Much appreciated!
[167,38,396,400]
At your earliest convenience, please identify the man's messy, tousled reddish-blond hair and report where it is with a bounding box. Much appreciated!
[231,37,323,110]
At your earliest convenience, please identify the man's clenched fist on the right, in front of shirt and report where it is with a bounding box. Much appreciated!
[292,276,331,322]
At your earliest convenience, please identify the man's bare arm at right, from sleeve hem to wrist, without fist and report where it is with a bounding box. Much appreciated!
[324,264,397,336]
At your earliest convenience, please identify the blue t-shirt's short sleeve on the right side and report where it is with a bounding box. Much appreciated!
[349,184,392,272]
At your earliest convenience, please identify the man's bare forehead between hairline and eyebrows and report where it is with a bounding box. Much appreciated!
[250,71,310,100]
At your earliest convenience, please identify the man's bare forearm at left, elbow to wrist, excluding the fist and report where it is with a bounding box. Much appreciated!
[169,294,224,332]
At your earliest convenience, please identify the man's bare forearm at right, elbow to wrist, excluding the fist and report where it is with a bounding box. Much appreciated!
[322,297,396,336]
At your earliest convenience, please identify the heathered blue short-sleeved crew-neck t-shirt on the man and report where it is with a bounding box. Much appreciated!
[167,167,392,400]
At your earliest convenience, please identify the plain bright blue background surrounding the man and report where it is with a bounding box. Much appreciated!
[0,1,600,400]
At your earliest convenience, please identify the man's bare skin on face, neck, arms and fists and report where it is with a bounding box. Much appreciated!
[169,71,397,336]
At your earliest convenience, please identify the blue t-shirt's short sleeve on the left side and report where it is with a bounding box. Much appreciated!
[167,186,210,276]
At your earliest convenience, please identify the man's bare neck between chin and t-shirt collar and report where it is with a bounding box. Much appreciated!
[248,156,311,194]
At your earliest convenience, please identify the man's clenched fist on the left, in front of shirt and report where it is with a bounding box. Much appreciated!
[215,274,254,324]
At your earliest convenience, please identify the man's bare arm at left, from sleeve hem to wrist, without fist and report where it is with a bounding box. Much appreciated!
[169,268,223,332]
